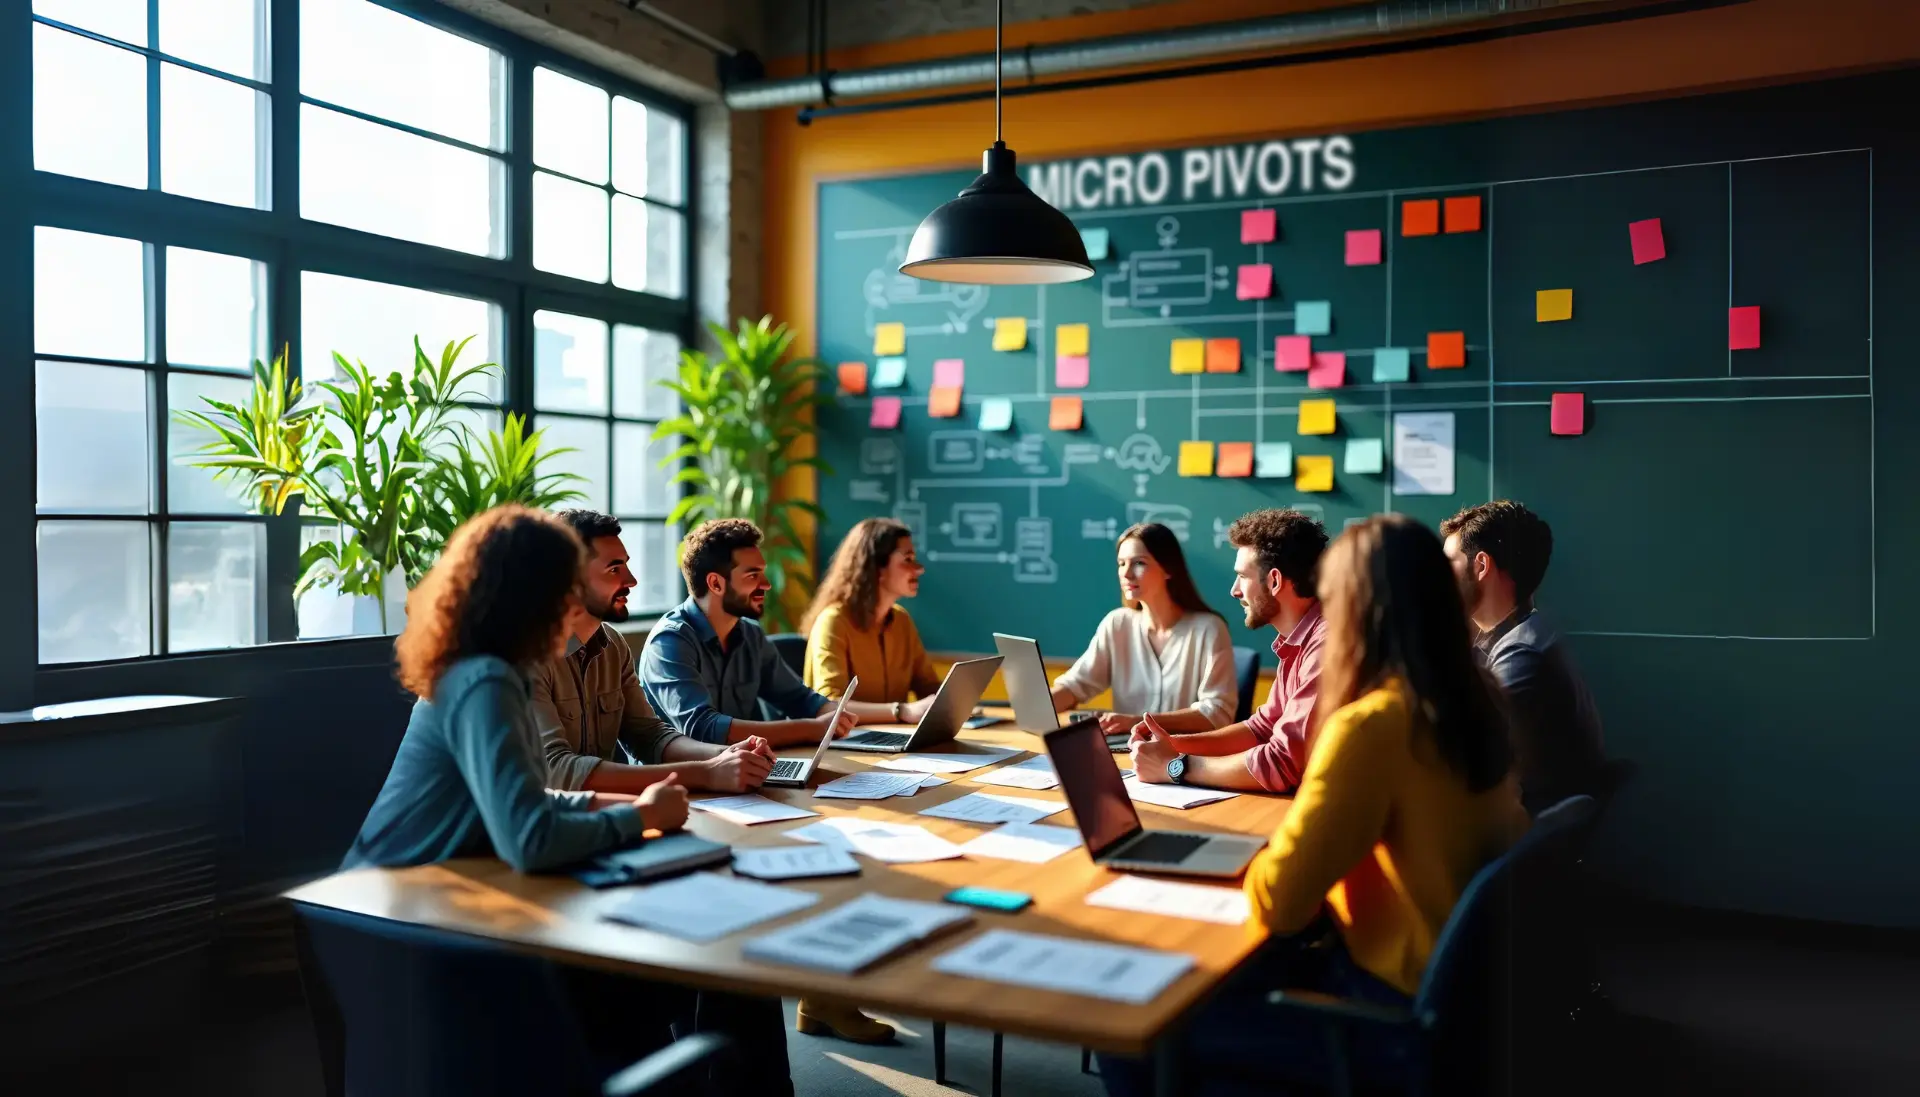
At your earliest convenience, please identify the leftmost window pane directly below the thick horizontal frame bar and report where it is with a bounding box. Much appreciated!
[33,225,146,361]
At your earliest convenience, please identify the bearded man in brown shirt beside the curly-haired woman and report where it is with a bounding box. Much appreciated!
[528,509,774,793]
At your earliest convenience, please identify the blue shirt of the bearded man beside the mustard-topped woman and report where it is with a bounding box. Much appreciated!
[639,597,828,744]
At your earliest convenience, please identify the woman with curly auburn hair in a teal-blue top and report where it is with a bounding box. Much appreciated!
[346,505,687,872]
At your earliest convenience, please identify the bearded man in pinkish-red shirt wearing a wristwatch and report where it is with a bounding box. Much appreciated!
[1133,509,1327,792]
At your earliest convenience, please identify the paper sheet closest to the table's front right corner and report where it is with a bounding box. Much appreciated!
[933,930,1194,1005]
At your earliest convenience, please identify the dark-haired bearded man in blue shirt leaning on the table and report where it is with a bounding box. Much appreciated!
[639,519,893,747]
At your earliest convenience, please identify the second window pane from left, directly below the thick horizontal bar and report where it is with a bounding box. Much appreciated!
[167,248,267,371]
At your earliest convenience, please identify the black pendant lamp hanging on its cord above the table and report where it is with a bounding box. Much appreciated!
[900,0,1092,286]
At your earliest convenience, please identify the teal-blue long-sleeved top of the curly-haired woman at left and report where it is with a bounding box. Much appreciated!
[342,655,645,872]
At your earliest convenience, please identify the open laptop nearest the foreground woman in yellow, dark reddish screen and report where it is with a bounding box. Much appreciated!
[1043,720,1265,878]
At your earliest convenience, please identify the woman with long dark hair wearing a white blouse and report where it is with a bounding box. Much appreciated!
[1054,523,1238,732]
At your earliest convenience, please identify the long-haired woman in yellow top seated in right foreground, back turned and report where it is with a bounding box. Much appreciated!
[1100,515,1526,1095]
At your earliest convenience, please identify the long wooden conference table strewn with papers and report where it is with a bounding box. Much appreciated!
[286,709,1292,1083]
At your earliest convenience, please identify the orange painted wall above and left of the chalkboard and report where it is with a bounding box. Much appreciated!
[762,0,1920,564]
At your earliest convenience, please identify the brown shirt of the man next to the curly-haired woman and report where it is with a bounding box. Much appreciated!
[528,624,680,790]
